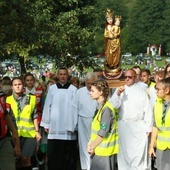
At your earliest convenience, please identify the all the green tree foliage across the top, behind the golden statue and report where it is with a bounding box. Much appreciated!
[0,0,170,72]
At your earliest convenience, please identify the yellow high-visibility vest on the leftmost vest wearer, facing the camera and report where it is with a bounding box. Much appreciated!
[6,95,36,138]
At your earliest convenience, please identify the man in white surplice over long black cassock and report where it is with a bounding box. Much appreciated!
[41,68,77,170]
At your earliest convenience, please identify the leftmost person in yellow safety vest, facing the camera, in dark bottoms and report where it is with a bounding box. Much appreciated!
[6,77,41,170]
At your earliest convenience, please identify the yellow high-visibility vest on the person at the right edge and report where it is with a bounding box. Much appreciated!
[154,99,170,150]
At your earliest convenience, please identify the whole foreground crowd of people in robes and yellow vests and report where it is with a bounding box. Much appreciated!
[0,64,170,170]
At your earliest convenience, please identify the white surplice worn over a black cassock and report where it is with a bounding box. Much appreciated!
[40,84,77,140]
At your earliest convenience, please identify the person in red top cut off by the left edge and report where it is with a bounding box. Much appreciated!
[0,91,21,170]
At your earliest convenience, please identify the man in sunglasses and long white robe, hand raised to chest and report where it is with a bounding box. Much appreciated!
[110,69,153,170]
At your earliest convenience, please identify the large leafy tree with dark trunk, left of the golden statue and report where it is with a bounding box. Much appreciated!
[0,0,99,73]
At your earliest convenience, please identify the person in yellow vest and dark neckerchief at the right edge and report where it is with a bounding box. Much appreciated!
[149,77,170,170]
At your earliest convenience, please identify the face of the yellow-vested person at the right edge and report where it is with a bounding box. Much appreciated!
[156,83,169,99]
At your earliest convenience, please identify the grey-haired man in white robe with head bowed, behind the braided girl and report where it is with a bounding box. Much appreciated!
[67,72,97,170]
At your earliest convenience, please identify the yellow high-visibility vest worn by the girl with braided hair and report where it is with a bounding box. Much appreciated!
[90,101,119,156]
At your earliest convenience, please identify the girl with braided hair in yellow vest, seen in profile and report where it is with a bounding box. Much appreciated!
[87,80,118,170]
